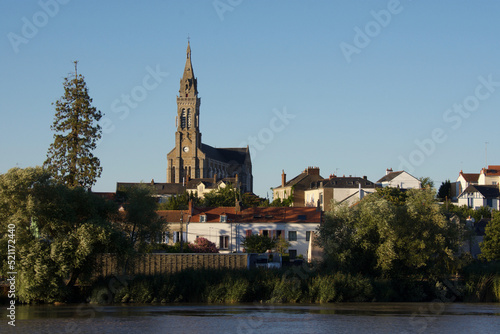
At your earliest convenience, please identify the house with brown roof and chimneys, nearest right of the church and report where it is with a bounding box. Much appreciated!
[273,167,323,207]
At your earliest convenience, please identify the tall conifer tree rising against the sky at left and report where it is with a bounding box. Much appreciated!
[44,61,102,189]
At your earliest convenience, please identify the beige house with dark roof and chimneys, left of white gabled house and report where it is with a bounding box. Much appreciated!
[304,174,380,211]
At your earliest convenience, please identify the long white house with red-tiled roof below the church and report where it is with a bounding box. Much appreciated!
[158,207,322,260]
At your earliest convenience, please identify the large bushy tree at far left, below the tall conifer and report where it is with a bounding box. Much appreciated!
[0,167,121,302]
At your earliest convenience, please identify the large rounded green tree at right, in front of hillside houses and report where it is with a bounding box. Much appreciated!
[319,187,462,278]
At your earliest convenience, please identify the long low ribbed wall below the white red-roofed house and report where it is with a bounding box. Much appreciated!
[96,253,248,276]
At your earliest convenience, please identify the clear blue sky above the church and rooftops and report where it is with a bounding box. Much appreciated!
[0,0,500,196]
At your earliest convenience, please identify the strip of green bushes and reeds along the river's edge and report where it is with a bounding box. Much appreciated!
[87,265,500,304]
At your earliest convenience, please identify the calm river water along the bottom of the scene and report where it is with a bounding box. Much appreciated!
[0,302,500,334]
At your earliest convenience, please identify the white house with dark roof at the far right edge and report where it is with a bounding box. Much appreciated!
[458,184,500,210]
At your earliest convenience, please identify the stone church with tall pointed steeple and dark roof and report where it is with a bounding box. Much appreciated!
[117,41,253,195]
